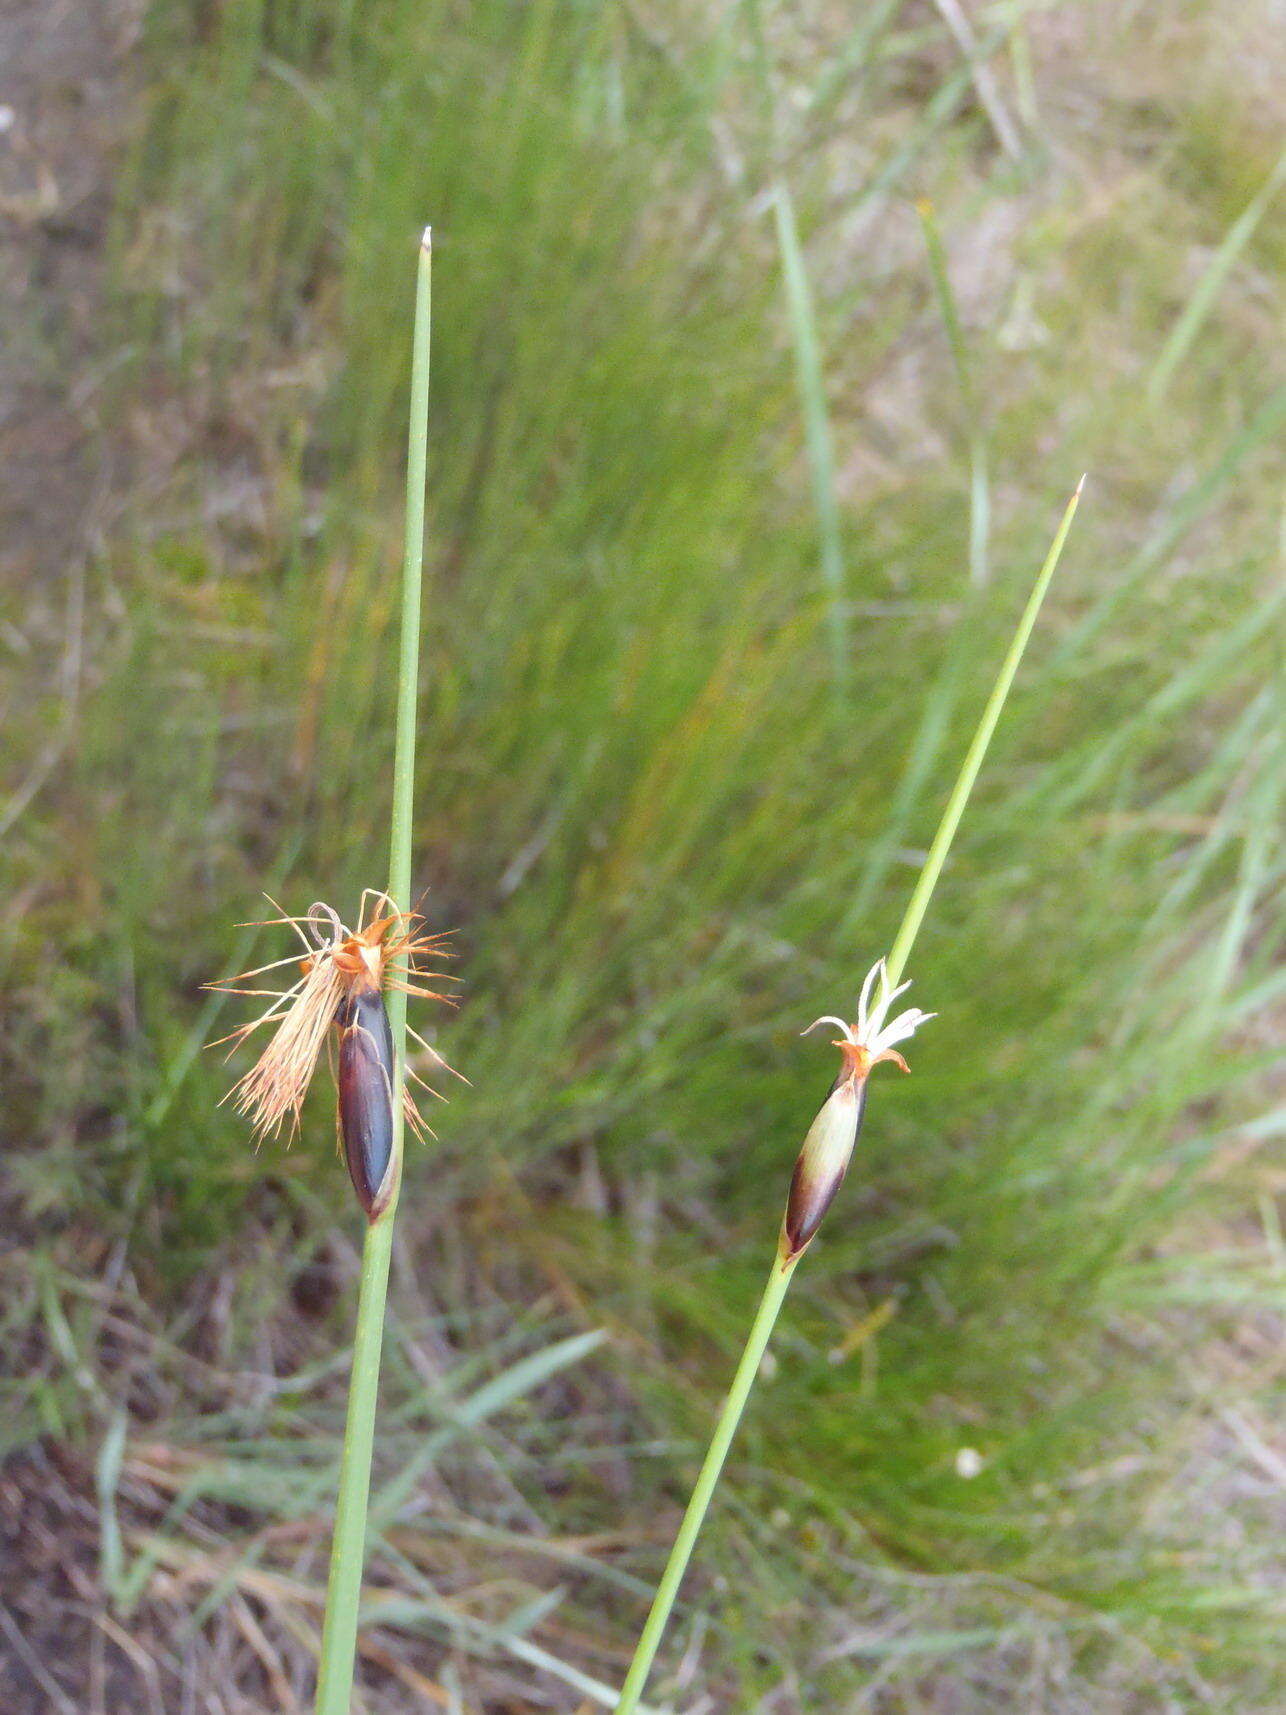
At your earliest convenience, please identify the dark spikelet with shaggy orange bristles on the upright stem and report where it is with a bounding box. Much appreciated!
[211,888,460,1221]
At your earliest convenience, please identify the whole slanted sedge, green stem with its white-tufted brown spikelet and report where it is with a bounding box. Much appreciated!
[616,477,1085,1715]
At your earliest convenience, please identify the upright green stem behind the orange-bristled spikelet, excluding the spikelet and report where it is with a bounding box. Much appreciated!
[317,230,432,1715]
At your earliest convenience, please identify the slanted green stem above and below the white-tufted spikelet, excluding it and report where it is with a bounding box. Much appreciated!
[616,477,1085,1715]
